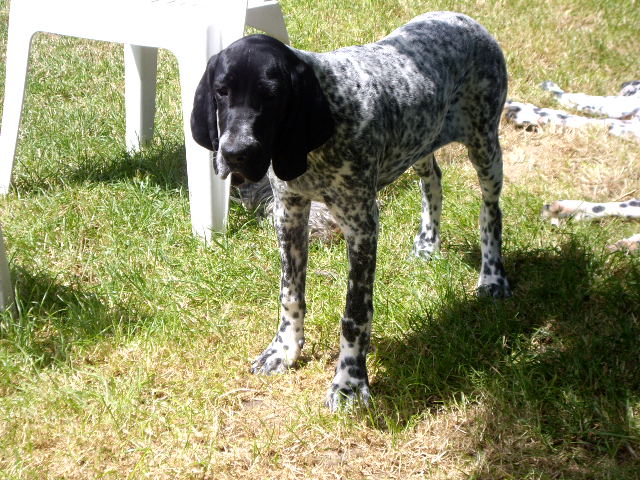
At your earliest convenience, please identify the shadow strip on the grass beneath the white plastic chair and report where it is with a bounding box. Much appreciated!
[14,142,187,192]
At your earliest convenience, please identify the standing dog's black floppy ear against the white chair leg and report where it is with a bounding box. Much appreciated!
[191,55,218,152]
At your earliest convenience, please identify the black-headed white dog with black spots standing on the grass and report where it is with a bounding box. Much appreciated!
[191,12,510,410]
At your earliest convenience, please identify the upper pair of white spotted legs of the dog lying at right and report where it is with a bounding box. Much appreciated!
[505,80,640,140]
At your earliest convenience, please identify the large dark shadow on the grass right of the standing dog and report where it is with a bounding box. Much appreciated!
[372,240,640,478]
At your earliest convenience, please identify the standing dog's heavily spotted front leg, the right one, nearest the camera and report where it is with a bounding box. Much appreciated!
[326,199,378,411]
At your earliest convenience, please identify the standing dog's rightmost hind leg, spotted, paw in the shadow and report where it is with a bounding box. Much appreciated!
[468,133,511,298]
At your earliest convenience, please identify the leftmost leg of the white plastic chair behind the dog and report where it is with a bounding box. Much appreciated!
[0,24,33,194]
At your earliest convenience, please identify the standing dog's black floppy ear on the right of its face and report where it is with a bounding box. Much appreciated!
[272,53,335,181]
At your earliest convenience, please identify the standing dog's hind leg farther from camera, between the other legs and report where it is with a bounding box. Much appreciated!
[413,154,442,259]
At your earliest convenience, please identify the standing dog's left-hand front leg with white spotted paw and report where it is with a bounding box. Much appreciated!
[251,191,311,374]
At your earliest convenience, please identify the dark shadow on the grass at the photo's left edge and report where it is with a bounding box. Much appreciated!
[0,267,146,369]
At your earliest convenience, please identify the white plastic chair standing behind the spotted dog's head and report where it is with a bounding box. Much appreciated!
[0,0,288,238]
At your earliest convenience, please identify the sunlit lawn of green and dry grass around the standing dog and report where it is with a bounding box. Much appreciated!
[0,0,640,480]
